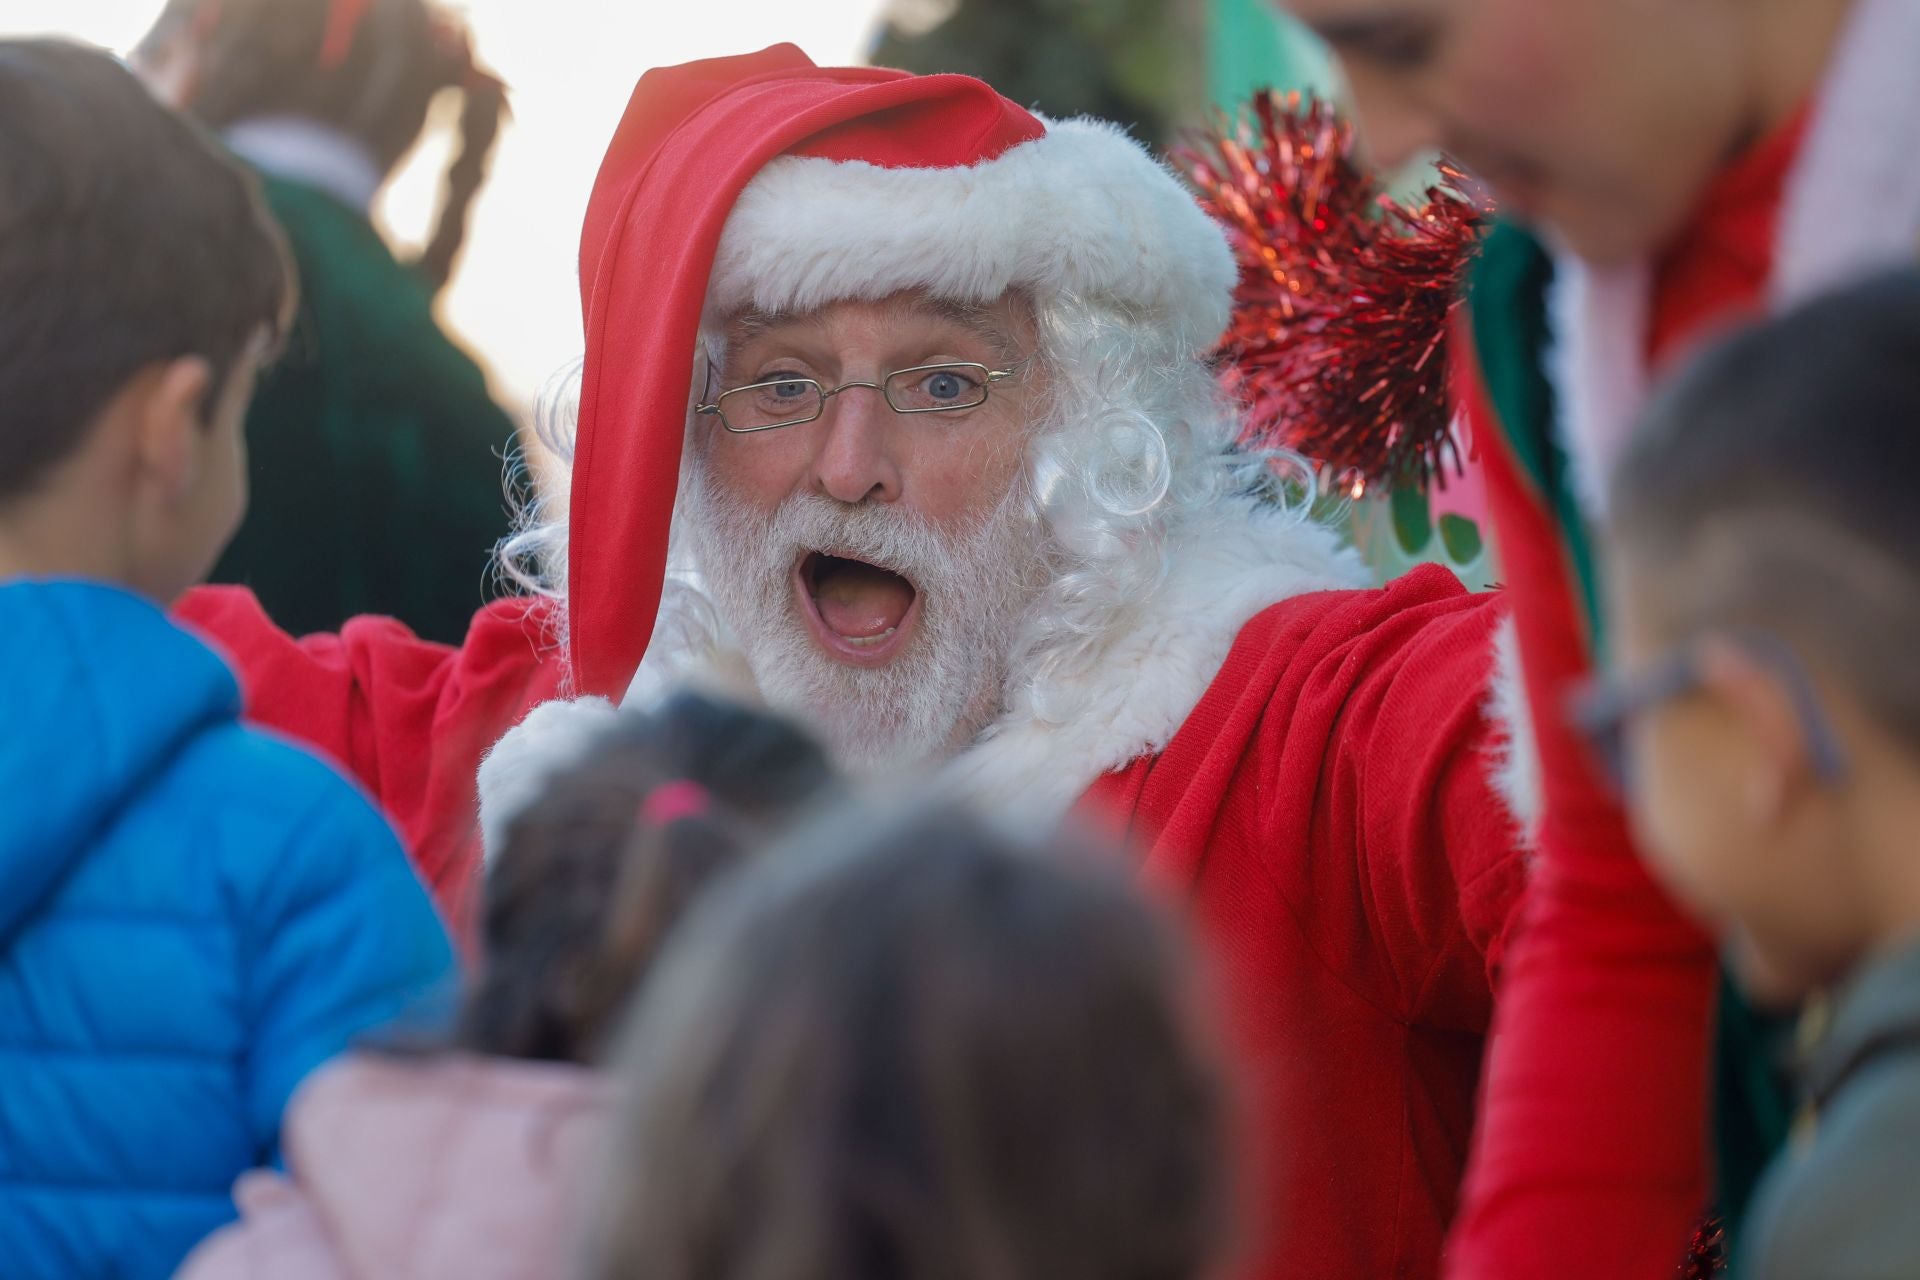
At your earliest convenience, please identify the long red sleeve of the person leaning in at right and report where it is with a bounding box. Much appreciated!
[1446,342,1716,1280]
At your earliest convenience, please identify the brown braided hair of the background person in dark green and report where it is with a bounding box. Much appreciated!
[138,0,507,288]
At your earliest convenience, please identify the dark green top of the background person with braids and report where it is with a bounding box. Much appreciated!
[213,177,515,641]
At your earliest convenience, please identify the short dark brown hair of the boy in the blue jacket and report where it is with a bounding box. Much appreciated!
[0,40,294,503]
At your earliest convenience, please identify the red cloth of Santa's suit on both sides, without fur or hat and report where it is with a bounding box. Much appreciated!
[180,568,1524,1280]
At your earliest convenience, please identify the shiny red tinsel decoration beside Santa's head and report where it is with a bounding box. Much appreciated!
[1173,92,1490,495]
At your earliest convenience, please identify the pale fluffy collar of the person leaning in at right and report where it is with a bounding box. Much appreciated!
[1548,0,1920,518]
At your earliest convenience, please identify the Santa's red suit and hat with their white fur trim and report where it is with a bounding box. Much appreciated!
[184,46,1523,1280]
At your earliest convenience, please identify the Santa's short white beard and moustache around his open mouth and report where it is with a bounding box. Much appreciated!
[682,464,1046,777]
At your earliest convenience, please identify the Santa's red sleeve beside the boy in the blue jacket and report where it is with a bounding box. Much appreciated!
[177,587,559,927]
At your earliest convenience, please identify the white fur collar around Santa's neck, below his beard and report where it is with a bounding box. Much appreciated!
[480,501,1367,848]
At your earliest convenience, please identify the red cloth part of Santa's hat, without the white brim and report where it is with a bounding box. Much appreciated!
[566,44,1044,699]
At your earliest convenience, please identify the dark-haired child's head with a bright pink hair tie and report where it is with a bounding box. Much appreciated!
[459,695,833,1061]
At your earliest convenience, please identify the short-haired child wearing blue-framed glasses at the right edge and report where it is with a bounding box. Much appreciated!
[1574,271,1920,1280]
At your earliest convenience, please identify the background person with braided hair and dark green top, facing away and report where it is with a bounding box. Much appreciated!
[134,0,515,641]
